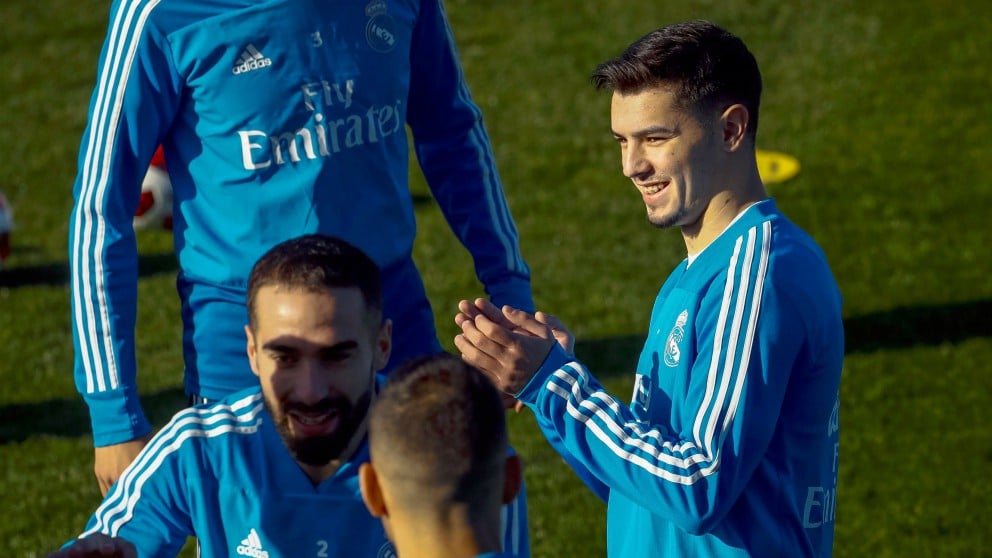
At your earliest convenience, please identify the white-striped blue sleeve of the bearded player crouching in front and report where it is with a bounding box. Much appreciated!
[71,413,201,556]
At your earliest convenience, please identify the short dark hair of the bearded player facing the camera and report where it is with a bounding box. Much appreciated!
[248,234,382,328]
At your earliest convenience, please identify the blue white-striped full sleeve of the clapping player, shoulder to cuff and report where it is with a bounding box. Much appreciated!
[518,258,803,534]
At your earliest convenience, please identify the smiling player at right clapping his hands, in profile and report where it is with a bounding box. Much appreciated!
[455,21,844,557]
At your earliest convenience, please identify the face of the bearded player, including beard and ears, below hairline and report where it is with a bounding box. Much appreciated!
[248,286,390,466]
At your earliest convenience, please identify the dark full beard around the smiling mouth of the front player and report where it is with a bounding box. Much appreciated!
[264,390,372,467]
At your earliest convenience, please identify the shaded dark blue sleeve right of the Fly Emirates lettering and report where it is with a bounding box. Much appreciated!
[407,0,534,312]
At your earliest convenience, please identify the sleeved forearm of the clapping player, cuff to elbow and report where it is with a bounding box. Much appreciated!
[517,347,730,532]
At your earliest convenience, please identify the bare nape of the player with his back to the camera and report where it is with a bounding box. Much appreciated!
[390,504,501,558]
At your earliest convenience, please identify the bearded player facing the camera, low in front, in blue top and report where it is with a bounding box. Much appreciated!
[54,235,527,558]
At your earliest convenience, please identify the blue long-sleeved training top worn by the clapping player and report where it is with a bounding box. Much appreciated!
[518,200,844,558]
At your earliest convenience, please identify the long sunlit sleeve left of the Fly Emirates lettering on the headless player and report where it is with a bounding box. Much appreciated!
[69,2,179,446]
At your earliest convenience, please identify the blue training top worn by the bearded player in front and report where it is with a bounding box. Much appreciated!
[67,387,530,558]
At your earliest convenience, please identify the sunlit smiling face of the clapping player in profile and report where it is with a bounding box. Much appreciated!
[611,87,721,231]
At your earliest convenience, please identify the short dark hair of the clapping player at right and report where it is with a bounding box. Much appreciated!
[592,20,761,139]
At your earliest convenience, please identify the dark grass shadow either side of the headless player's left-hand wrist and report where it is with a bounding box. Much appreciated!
[0,387,186,445]
